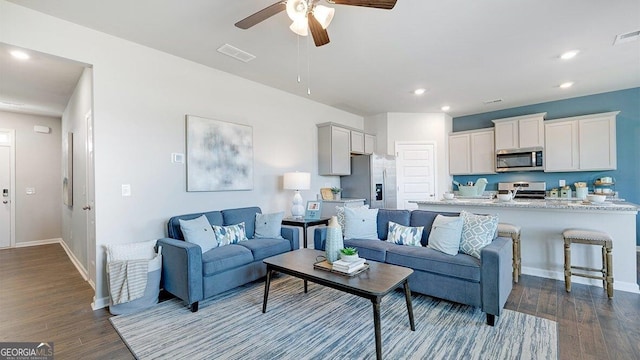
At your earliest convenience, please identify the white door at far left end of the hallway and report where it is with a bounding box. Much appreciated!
[0,129,15,248]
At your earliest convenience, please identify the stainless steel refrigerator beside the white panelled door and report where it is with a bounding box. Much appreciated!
[340,154,398,209]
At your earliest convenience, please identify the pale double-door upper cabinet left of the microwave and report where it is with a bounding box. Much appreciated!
[449,129,496,175]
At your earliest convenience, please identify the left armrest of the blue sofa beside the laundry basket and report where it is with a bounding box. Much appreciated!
[158,238,204,306]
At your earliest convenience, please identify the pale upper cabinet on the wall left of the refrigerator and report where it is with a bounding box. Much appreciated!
[318,123,351,175]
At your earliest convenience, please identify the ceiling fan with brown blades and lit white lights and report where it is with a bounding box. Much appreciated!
[235,0,397,46]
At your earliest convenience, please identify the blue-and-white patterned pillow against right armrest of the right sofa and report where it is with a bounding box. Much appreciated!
[460,210,498,259]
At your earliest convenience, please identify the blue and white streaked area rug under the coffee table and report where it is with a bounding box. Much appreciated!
[111,275,558,360]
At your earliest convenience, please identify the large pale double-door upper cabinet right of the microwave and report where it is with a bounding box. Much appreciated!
[544,111,619,172]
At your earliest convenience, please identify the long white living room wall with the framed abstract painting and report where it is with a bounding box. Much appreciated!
[0,0,363,303]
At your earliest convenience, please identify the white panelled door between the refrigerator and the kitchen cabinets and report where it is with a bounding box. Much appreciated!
[396,142,436,209]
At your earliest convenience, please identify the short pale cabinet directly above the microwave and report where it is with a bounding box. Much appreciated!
[492,113,547,150]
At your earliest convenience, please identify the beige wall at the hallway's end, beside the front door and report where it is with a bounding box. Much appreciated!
[0,111,62,245]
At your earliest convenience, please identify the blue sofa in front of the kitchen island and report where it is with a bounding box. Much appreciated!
[314,209,513,326]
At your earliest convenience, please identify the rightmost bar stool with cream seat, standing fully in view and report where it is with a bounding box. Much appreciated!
[562,229,613,299]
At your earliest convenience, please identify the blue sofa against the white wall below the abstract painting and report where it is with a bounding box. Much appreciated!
[158,207,300,312]
